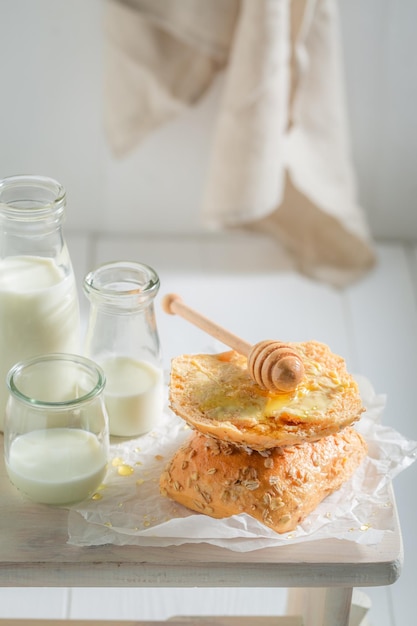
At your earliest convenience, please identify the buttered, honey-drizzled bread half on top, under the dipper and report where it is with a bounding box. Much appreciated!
[170,341,364,450]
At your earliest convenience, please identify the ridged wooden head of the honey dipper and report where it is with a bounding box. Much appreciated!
[248,340,304,393]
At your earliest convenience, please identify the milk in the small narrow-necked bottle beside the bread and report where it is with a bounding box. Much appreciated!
[101,356,163,437]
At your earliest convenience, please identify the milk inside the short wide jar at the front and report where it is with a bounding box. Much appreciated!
[6,428,107,504]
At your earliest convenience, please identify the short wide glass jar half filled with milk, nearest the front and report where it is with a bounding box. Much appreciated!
[4,354,109,505]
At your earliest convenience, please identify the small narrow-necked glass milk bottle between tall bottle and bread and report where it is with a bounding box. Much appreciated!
[84,261,163,437]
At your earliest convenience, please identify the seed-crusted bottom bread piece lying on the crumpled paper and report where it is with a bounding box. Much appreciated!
[160,427,367,533]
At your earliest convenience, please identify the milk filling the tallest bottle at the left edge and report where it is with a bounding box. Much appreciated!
[0,256,79,430]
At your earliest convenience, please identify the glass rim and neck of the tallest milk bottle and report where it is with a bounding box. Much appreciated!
[0,175,66,221]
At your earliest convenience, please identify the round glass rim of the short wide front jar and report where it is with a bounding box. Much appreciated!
[6,352,106,409]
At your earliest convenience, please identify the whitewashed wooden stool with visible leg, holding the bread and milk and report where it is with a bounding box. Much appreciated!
[0,437,402,626]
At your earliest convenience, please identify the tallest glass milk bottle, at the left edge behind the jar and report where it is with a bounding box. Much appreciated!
[0,176,80,430]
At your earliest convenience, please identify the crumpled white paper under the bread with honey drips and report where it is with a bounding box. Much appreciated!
[68,377,417,552]
